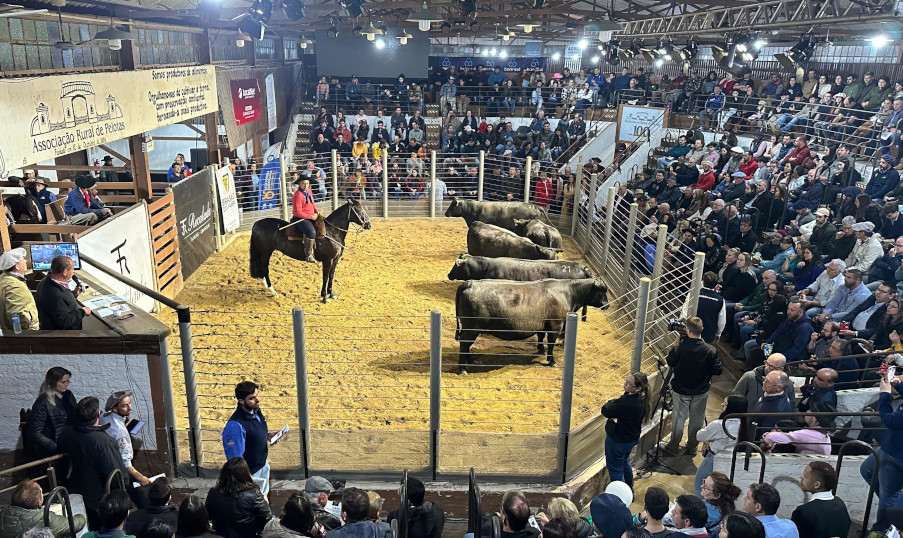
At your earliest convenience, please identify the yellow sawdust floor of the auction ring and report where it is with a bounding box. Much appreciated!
[159,218,631,465]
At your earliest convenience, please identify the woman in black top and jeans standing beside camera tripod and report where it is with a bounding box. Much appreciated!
[602,372,649,488]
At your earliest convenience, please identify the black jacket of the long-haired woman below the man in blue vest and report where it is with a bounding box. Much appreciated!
[204,487,273,538]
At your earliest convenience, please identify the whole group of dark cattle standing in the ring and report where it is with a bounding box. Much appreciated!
[445,198,608,369]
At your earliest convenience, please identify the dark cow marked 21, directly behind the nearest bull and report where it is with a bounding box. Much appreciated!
[448,254,593,282]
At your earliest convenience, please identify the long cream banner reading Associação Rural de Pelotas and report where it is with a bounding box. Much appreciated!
[0,65,219,176]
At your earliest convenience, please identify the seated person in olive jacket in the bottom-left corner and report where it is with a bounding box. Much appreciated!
[0,480,86,538]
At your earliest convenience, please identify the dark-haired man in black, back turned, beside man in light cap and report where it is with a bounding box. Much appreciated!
[58,396,131,530]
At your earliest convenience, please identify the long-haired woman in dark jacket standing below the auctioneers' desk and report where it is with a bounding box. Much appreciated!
[26,366,77,459]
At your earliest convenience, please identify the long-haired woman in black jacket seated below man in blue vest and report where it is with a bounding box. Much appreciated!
[205,457,272,538]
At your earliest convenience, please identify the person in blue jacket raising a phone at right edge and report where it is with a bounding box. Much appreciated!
[859,375,903,531]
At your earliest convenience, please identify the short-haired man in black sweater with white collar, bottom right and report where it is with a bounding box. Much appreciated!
[790,461,850,538]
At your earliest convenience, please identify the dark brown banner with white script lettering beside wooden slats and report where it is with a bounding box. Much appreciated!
[172,169,216,280]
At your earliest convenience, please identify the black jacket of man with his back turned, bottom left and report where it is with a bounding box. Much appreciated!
[57,424,129,510]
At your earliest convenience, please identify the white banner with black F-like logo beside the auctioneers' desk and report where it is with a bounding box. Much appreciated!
[78,203,157,312]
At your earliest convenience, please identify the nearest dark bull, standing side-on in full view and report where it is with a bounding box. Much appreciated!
[455,278,608,368]
